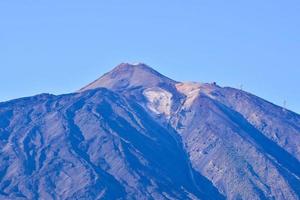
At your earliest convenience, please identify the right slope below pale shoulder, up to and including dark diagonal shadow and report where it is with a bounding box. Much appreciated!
[170,91,300,199]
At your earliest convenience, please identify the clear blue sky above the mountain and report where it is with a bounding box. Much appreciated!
[0,0,300,113]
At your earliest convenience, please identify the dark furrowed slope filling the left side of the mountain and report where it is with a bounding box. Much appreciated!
[0,89,222,199]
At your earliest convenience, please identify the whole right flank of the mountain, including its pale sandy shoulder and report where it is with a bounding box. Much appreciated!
[171,83,300,199]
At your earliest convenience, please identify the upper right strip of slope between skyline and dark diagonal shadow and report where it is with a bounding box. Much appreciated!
[215,88,300,160]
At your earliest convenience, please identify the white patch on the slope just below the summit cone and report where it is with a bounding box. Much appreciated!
[144,88,172,117]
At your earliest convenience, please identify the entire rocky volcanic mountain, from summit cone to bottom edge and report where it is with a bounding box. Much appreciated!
[0,63,300,200]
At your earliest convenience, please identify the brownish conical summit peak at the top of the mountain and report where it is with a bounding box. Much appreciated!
[80,63,176,91]
